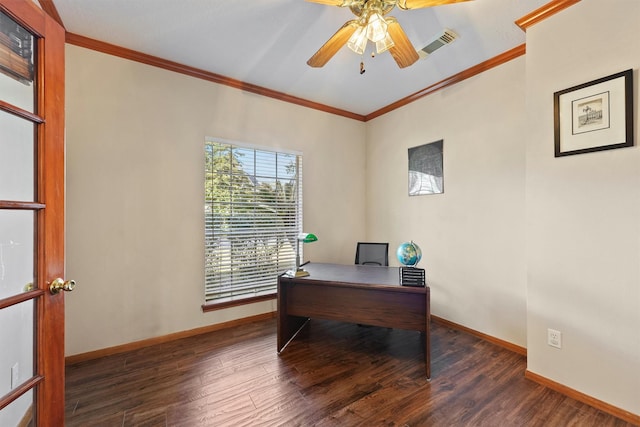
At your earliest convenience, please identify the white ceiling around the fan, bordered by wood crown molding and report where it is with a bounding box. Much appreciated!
[53,0,549,115]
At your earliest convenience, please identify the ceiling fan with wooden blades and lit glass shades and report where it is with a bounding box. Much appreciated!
[307,0,469,68]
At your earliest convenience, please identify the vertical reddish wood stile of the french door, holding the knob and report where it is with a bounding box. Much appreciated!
[35,8,65,426]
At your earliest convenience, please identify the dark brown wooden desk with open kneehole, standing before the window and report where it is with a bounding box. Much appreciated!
[278,263,431,378]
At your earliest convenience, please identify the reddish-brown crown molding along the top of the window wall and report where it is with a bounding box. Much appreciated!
[66,33,364,121]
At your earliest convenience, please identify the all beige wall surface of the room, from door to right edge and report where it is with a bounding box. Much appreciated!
[66,0,640,414]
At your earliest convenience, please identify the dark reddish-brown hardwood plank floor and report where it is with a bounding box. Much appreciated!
[66,319,631,427]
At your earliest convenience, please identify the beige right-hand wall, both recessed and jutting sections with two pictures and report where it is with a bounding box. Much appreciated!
[366,0,640,414]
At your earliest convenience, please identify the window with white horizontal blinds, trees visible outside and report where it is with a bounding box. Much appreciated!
[204,140,302,305]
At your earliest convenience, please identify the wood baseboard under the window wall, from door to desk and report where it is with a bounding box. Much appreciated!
[65,312,276,365]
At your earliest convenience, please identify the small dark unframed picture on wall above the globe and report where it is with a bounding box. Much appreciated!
[409,140,444,196]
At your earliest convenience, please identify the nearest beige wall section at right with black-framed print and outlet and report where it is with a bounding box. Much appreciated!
[526,0,640,414]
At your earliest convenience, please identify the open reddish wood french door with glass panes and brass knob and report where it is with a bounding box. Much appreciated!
[0,0,68,427]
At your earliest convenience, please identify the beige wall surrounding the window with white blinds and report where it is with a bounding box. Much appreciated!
[66,45,365,355]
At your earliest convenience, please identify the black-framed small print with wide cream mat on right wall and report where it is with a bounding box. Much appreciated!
[553,70,633,157]
